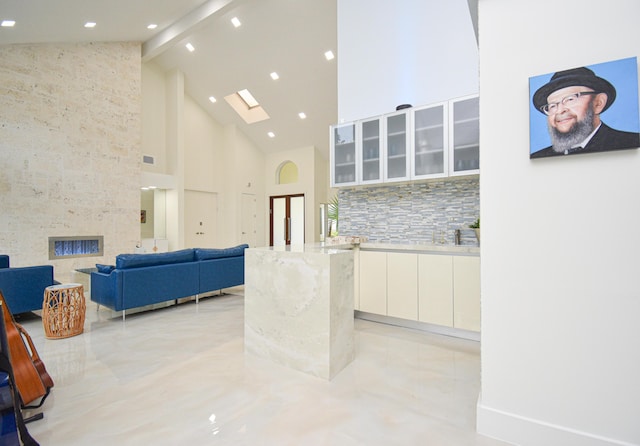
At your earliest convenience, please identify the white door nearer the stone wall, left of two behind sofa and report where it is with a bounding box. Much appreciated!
[184,190,218,248]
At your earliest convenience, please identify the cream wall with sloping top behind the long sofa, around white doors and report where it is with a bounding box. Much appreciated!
[143,63,265,250]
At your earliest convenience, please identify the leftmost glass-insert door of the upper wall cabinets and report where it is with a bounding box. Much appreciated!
[331,123,357,185]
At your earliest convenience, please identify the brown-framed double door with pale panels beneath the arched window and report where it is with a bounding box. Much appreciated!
[269,194,304,246]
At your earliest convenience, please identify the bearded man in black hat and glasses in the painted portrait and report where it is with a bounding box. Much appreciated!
[531,67,640,158]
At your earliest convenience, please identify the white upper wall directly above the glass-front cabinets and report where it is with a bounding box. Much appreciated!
[337,0,478,122]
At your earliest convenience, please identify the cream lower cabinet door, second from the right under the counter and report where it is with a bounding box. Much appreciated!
[418,254,453,327]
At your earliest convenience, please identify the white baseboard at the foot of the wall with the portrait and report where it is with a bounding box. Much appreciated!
[476,396,637,446]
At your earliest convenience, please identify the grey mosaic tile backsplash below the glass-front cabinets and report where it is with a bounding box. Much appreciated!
[338,177,480,245]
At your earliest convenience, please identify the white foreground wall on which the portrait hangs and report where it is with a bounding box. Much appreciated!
[478,0,640,446]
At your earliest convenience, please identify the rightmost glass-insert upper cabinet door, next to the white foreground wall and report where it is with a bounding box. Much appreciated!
[451,96,480,174]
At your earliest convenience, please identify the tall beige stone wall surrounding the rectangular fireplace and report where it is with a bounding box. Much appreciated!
[0,42,141,281]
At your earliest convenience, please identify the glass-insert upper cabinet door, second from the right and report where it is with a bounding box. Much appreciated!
[412,104,448,178]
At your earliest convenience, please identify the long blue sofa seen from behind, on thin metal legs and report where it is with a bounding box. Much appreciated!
[91,245,249,316]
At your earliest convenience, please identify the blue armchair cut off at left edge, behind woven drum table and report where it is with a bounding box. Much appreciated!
[0,255,57,314]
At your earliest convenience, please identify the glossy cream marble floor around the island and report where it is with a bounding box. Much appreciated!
[19,287,506,446]
